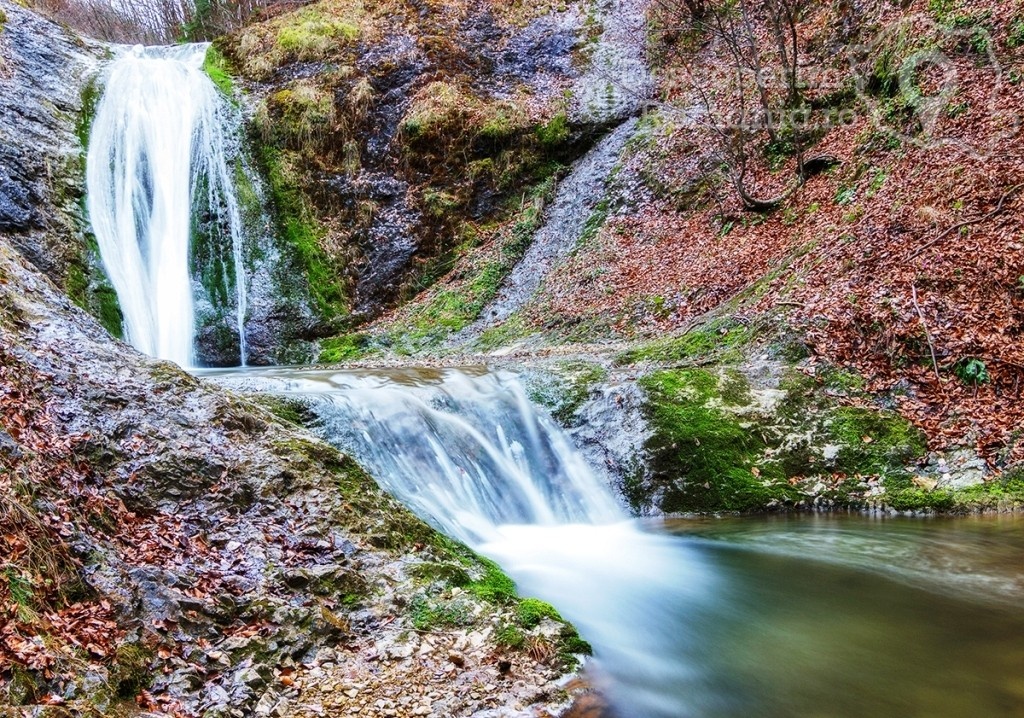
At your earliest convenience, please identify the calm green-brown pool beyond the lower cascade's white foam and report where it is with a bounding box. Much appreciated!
[569,516,1024,718]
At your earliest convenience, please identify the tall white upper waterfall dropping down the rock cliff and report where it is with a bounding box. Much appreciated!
[86,44,247,367]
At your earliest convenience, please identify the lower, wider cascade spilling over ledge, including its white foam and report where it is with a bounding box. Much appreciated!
[207,368,721,718]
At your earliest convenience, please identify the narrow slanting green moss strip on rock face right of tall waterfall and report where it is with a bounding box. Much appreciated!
[262,146,348,320]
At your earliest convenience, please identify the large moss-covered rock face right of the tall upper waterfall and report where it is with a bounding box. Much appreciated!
[226,0,595,327]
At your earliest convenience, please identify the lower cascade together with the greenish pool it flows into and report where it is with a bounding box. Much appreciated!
[203,369,1024,718]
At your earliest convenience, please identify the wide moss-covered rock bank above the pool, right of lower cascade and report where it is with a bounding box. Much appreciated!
[625,360,941,512]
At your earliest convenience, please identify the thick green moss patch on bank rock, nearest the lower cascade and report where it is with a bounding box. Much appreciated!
[640,370,799,512]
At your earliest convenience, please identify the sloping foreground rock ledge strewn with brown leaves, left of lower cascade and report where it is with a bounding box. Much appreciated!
[0,240,586,717]
